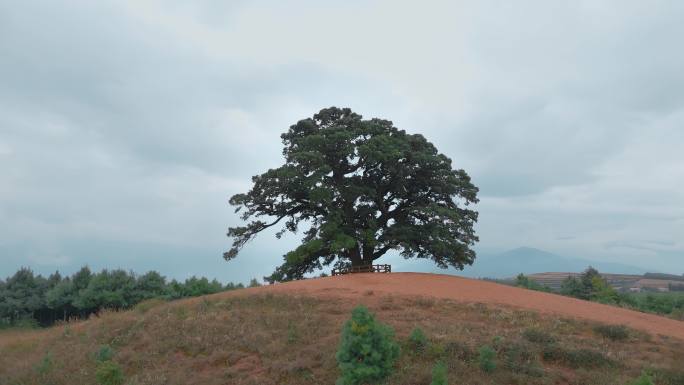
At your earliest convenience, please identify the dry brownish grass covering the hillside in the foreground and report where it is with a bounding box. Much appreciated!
[0,290,684,385]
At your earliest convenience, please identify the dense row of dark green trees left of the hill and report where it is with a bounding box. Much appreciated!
[0,266,254,328]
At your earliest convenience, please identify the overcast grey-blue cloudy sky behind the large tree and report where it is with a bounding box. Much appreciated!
[0,0,684,281]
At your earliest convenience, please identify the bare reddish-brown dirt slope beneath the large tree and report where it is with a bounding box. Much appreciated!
[246,273,684,340]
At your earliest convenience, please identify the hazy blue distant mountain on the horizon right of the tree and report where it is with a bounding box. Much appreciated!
[388,247,646,278]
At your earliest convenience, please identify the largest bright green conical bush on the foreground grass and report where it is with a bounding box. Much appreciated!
[336,306,399,385]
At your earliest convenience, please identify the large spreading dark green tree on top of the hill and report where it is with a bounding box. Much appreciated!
[224,107,478,281]
